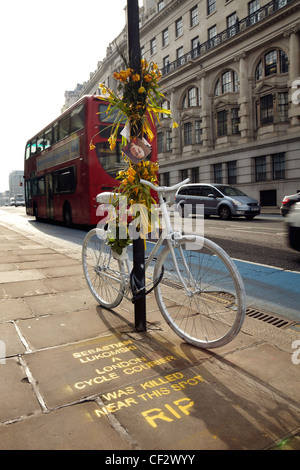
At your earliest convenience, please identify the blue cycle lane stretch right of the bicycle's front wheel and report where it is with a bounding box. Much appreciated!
[234,259,300,322]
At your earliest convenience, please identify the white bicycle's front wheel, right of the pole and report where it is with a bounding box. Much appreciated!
[154,236,246,349]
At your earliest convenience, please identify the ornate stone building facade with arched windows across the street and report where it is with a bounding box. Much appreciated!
[64,0,300,206]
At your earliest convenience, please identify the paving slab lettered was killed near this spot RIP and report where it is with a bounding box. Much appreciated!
[100,361,300,450]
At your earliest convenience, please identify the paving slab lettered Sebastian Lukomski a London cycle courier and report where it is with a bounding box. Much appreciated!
[25,335,186,408]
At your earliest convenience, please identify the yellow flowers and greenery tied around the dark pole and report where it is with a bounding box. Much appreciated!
[90,59,178,254]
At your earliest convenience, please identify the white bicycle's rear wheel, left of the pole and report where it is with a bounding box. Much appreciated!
[82,228,125,308]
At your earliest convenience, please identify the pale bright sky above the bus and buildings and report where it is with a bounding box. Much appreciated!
[0,0,127,192]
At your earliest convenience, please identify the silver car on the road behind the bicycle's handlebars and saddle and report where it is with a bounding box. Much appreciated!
[175,183,260,220]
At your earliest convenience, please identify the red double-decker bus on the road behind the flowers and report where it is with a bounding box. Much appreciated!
[24,96,157,226]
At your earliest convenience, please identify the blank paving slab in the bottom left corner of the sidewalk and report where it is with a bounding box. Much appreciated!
[0,403,132,451]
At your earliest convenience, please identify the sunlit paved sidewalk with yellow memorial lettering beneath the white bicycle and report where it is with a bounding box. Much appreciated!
[0,225,300,451]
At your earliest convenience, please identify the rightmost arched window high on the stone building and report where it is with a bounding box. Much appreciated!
[255,49,289,80]
